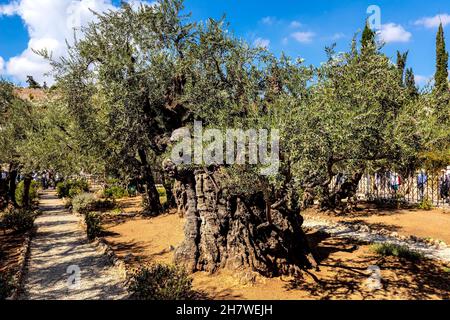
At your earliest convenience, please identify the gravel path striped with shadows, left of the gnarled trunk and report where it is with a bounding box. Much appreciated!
[21,191,127,300]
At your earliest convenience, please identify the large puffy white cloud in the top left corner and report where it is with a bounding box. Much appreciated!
[0,0,152,84]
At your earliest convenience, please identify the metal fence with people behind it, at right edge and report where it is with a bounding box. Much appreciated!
[348,171,450,207]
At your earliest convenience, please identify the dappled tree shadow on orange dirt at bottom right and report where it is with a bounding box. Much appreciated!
[285,235,450,300]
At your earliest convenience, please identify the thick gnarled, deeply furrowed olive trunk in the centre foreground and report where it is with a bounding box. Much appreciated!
[164,162,317,276]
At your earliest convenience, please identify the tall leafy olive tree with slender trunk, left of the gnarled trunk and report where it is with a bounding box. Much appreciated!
[41,0,195,215]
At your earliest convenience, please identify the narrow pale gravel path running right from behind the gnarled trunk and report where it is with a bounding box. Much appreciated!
[303,218,450,263]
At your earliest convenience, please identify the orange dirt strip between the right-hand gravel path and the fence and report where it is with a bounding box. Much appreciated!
[303,208,450,245]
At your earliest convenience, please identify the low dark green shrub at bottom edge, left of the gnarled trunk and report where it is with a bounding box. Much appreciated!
[129,264,194,300]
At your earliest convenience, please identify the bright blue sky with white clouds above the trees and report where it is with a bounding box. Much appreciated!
[0,0,450,84]
